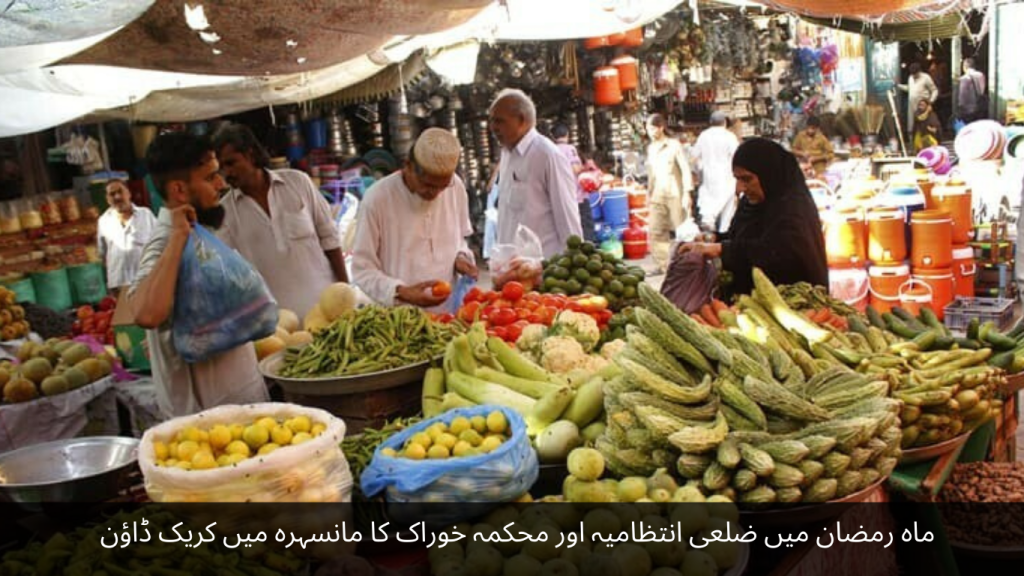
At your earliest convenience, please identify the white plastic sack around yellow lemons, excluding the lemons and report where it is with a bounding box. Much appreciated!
[138,403,352,502]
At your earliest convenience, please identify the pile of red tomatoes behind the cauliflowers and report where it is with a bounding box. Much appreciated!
[437,281,613,342]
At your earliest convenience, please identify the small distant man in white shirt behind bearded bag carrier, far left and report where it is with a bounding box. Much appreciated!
[96,179,157,296]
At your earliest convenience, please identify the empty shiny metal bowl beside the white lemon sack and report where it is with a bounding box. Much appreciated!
[0,436,138,503]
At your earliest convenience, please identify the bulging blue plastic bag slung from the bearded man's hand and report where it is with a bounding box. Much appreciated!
[173,225,278,364]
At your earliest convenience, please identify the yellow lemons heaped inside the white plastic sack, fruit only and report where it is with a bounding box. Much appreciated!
[153,416,327,470]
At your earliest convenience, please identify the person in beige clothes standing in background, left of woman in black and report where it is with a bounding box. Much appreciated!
[647,114,693,273]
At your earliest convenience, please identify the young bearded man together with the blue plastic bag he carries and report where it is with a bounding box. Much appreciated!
[129,132,278,416]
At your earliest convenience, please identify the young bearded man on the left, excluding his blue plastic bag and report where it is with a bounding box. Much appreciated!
[128,132,268,416]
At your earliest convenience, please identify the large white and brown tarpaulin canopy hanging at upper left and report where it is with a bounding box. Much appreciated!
[0,0,680,137]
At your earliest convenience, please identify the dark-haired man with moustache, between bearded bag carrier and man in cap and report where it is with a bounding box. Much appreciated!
[213,124,348,318]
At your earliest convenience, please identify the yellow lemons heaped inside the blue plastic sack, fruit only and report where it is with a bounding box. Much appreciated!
[381,410,510,460]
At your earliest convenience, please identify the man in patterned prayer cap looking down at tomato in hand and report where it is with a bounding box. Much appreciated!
[352,128,478,312]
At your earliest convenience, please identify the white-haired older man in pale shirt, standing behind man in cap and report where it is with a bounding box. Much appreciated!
[489,89,583,258]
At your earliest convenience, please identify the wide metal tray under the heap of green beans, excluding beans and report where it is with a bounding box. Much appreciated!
[259,351,442,396]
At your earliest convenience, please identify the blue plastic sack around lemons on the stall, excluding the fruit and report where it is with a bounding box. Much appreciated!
[359,406,540,502]
